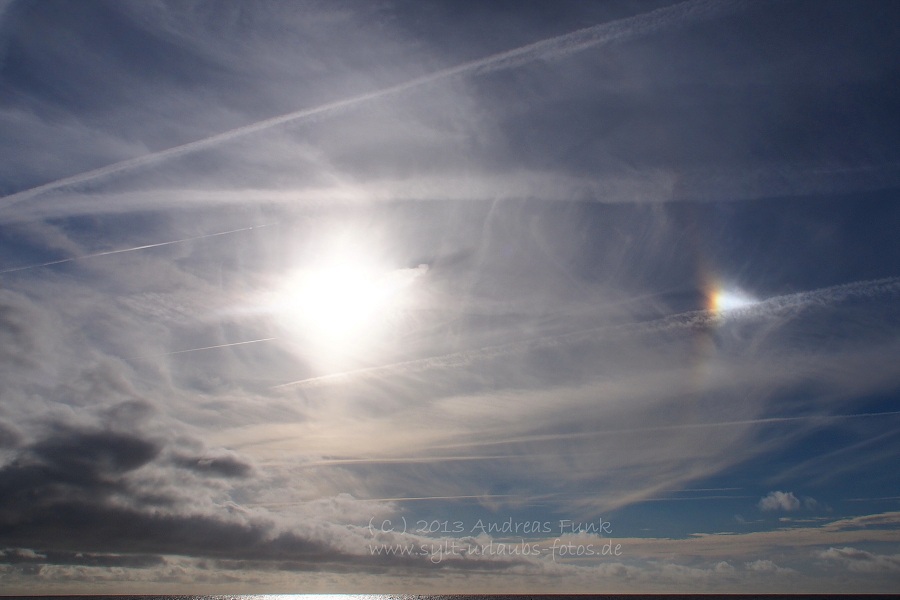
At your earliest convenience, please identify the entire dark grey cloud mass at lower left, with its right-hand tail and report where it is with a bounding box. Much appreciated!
[0,403,521,573]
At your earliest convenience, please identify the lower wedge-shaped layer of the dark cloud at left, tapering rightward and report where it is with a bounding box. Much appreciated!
[0,469,522,573]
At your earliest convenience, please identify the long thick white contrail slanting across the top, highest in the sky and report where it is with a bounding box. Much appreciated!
[0,0,746,208]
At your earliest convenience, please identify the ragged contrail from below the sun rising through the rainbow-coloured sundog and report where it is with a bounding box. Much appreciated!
[272,277,900,389]
